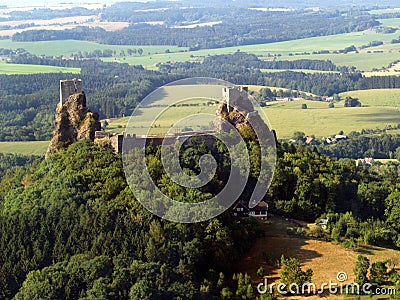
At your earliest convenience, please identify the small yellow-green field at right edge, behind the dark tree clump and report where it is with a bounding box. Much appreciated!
[340,89,400,106]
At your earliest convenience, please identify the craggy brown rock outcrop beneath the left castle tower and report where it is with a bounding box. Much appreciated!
[46,92,101,158]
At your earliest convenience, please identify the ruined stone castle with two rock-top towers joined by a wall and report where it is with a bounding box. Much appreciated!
[50,78,268,153]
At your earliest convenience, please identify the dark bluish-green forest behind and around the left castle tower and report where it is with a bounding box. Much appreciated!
[0,60,181,141]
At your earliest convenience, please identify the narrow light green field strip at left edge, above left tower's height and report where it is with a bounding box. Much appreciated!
[0,61,81,74]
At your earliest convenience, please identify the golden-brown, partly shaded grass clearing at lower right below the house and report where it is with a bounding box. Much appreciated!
[238,217,400,300]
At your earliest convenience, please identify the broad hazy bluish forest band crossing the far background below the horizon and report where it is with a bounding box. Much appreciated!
[12,8,380,50]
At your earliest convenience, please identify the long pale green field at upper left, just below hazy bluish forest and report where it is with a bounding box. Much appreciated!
[0,40,187,57]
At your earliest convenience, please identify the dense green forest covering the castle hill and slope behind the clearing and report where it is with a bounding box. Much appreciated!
[0,140,400,299]
